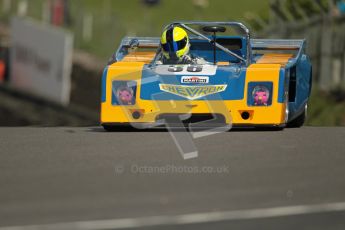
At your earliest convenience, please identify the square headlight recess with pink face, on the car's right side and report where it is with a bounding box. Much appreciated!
[247,82,273,106]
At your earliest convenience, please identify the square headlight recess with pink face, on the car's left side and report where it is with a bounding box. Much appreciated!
[111,81,137,105]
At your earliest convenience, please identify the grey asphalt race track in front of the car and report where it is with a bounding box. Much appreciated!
[0,127,345,230]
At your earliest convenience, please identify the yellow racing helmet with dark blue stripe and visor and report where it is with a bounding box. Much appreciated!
[161,27,189,59]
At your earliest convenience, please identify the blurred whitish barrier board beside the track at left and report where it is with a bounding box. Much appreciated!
[10,18,73,105]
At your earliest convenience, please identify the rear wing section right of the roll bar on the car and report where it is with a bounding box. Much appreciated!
[251,39,306,65]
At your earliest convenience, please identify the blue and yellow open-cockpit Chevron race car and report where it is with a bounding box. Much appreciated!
[100,21,312,131]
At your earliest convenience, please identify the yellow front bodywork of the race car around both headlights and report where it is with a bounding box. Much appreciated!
[100,55,290,126]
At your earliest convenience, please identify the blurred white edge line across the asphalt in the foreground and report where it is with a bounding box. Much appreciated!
[0,202,345,230]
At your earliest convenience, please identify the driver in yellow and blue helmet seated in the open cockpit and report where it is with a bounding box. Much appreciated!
[160,26,208,65]
